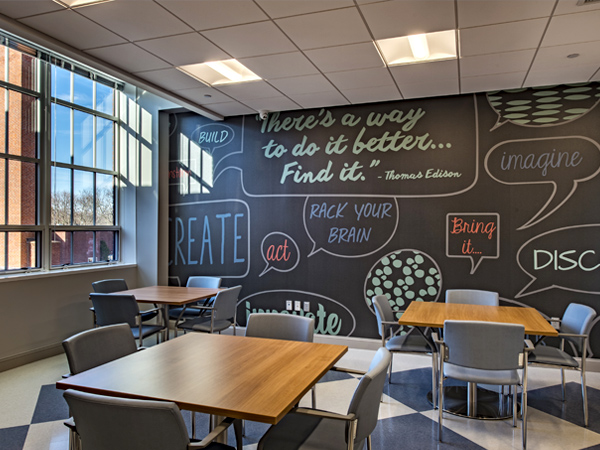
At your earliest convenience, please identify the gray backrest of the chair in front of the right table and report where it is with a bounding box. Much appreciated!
[444,320,525,370]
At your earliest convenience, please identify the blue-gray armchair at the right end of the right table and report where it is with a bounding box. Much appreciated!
[529,303,596,427]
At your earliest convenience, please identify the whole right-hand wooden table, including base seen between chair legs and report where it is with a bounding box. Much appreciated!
[398,302,558,419]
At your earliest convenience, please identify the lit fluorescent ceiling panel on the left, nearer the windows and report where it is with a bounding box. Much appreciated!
[177,59,261,86]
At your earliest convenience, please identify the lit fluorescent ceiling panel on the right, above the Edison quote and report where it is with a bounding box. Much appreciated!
[376,30,457,66]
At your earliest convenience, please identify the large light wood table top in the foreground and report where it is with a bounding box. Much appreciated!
[56,333,348,424]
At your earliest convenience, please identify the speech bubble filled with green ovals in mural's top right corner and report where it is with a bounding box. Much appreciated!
[486,82,600,131]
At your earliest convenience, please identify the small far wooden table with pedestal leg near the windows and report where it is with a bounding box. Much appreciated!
[115,286,223,340]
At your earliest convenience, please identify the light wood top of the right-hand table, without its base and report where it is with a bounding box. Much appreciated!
[398,302,558,336]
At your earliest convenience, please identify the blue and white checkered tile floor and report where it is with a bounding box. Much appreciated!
[0,349,600,450]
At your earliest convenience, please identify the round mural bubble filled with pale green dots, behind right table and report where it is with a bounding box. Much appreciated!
[365,249,442,318]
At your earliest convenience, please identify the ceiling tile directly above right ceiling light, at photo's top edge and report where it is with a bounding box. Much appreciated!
[360,0,456,39]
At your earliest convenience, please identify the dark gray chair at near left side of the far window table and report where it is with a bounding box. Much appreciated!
[90,293,165,347]
